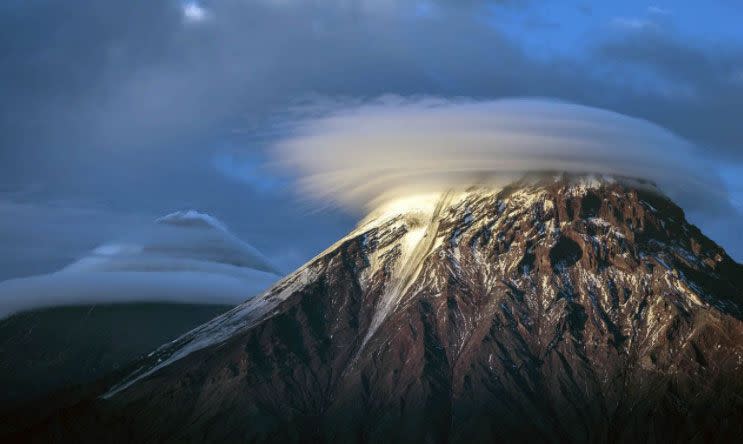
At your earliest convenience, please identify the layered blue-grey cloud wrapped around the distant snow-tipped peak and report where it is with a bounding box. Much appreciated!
[0,211,280,319]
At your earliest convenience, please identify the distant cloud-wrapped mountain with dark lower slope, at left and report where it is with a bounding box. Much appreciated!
[0,210,280,416]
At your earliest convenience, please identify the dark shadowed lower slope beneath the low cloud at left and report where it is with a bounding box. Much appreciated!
[0,303,231,410]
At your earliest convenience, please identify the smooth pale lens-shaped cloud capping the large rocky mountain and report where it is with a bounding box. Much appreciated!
[274,97,721,209]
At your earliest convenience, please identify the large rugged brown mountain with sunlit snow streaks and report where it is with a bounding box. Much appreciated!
[10,176,743,442]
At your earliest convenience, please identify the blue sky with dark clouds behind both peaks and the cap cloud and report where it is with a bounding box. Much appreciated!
[0,0,743,280]
